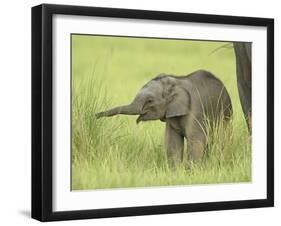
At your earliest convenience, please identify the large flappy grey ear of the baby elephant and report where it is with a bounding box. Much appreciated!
[166,82,191,118]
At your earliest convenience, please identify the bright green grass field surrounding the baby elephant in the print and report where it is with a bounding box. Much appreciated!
[72,35,251,190]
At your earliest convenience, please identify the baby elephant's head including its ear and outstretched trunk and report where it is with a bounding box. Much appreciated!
[96,74,190,123]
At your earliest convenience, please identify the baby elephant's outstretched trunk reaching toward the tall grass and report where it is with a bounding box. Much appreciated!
[96,103,141,118]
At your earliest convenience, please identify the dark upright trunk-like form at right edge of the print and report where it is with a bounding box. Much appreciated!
[233,42,252,133]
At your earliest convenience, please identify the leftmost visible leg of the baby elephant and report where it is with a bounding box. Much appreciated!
[165,123,184,167]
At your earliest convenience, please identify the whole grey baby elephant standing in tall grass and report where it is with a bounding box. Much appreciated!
[96,70,232,166]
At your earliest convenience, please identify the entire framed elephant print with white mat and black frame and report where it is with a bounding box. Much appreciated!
[32,4,274,221]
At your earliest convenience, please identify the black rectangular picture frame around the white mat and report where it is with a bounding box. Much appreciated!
[32,4,274,221]
